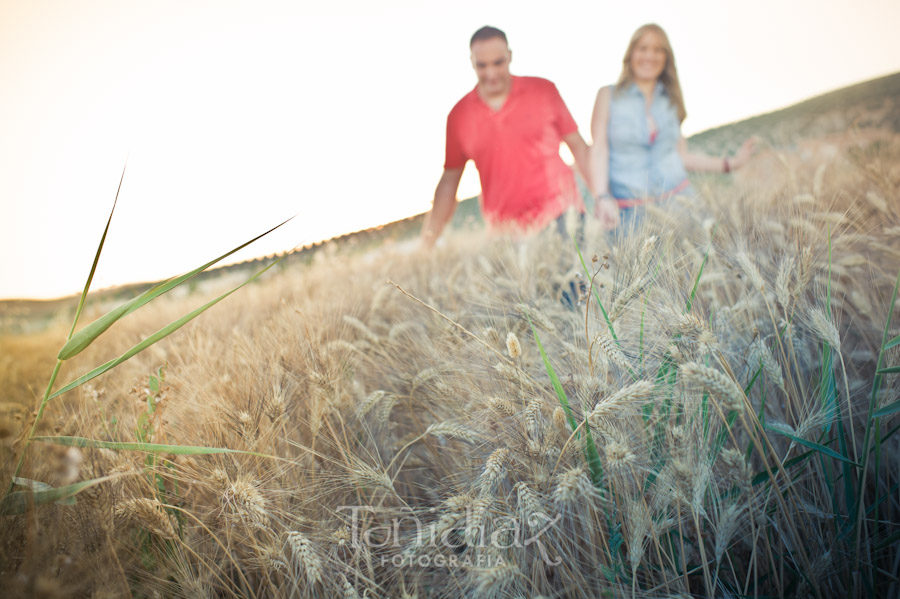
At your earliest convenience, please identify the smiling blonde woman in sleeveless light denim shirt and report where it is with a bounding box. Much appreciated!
[591,24,755,228]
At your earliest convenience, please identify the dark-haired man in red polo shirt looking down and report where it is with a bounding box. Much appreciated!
[422,27,590,248]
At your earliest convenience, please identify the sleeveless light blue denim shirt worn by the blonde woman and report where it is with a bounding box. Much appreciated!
[607,82,687,199]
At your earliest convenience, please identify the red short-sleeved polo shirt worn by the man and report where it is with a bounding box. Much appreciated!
[444,76,584,228]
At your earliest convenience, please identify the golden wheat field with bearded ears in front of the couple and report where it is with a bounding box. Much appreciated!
[0,132,900,599]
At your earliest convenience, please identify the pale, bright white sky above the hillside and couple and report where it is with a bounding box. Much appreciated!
[0,0,900,298]
